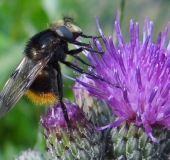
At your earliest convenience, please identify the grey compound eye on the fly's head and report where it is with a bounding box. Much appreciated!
[54,26,74,41]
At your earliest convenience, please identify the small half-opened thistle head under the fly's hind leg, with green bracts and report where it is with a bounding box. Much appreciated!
[41,100,104,160]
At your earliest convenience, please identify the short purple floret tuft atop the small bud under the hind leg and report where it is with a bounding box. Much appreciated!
[41,99,86,131]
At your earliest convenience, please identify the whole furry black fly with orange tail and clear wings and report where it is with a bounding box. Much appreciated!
[0,17,107,125]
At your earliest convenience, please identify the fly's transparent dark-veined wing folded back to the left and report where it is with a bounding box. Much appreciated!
[0,55,51,118]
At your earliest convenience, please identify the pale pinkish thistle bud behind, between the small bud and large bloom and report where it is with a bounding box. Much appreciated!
[72,76,114,126]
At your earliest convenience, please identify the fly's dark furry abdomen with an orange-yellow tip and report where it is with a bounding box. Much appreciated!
[25,65,58,104]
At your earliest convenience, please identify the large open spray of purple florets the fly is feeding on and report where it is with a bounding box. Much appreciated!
[77,18,170,142]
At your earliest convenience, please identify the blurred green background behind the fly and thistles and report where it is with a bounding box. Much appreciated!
[0,0,170,160]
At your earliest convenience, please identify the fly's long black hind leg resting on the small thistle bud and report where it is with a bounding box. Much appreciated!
[53,62,71,129]
